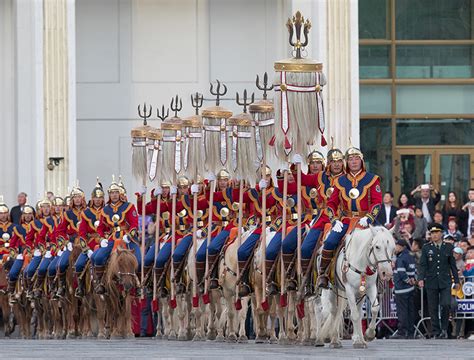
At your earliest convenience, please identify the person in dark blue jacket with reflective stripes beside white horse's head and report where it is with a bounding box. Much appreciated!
[390,240,416,339]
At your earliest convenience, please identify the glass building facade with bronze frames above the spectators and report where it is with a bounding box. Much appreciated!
[359,0,474,202]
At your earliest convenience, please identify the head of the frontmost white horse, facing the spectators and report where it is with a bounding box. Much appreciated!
[369,226,395,281]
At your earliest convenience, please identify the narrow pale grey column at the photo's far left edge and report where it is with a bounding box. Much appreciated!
[0,0,17,205]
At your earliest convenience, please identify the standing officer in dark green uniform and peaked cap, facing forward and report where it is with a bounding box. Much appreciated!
[418,223,459,339]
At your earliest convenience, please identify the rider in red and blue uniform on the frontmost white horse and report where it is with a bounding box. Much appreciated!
[317,146,382,288]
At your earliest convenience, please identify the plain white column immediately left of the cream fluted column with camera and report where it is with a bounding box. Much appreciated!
[14,0,47,204]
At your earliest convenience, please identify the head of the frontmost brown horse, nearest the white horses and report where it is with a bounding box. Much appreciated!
[110,247,139,293]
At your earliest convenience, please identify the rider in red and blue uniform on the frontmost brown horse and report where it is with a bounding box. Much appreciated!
[91,179,138,295]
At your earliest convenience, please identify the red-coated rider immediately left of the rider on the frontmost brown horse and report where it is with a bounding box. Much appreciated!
[74,180,105,298]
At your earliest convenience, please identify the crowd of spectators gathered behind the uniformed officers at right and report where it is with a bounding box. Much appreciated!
[377,185,474,338]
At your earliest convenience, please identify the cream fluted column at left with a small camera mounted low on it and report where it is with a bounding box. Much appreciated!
[43,0,76,196]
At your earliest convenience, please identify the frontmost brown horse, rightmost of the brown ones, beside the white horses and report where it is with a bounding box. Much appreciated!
[105,247,140,338]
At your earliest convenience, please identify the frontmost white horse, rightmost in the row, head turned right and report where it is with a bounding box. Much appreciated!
[318,226,395,348]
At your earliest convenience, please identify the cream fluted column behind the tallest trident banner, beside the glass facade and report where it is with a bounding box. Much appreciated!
[291,0,359,151]
